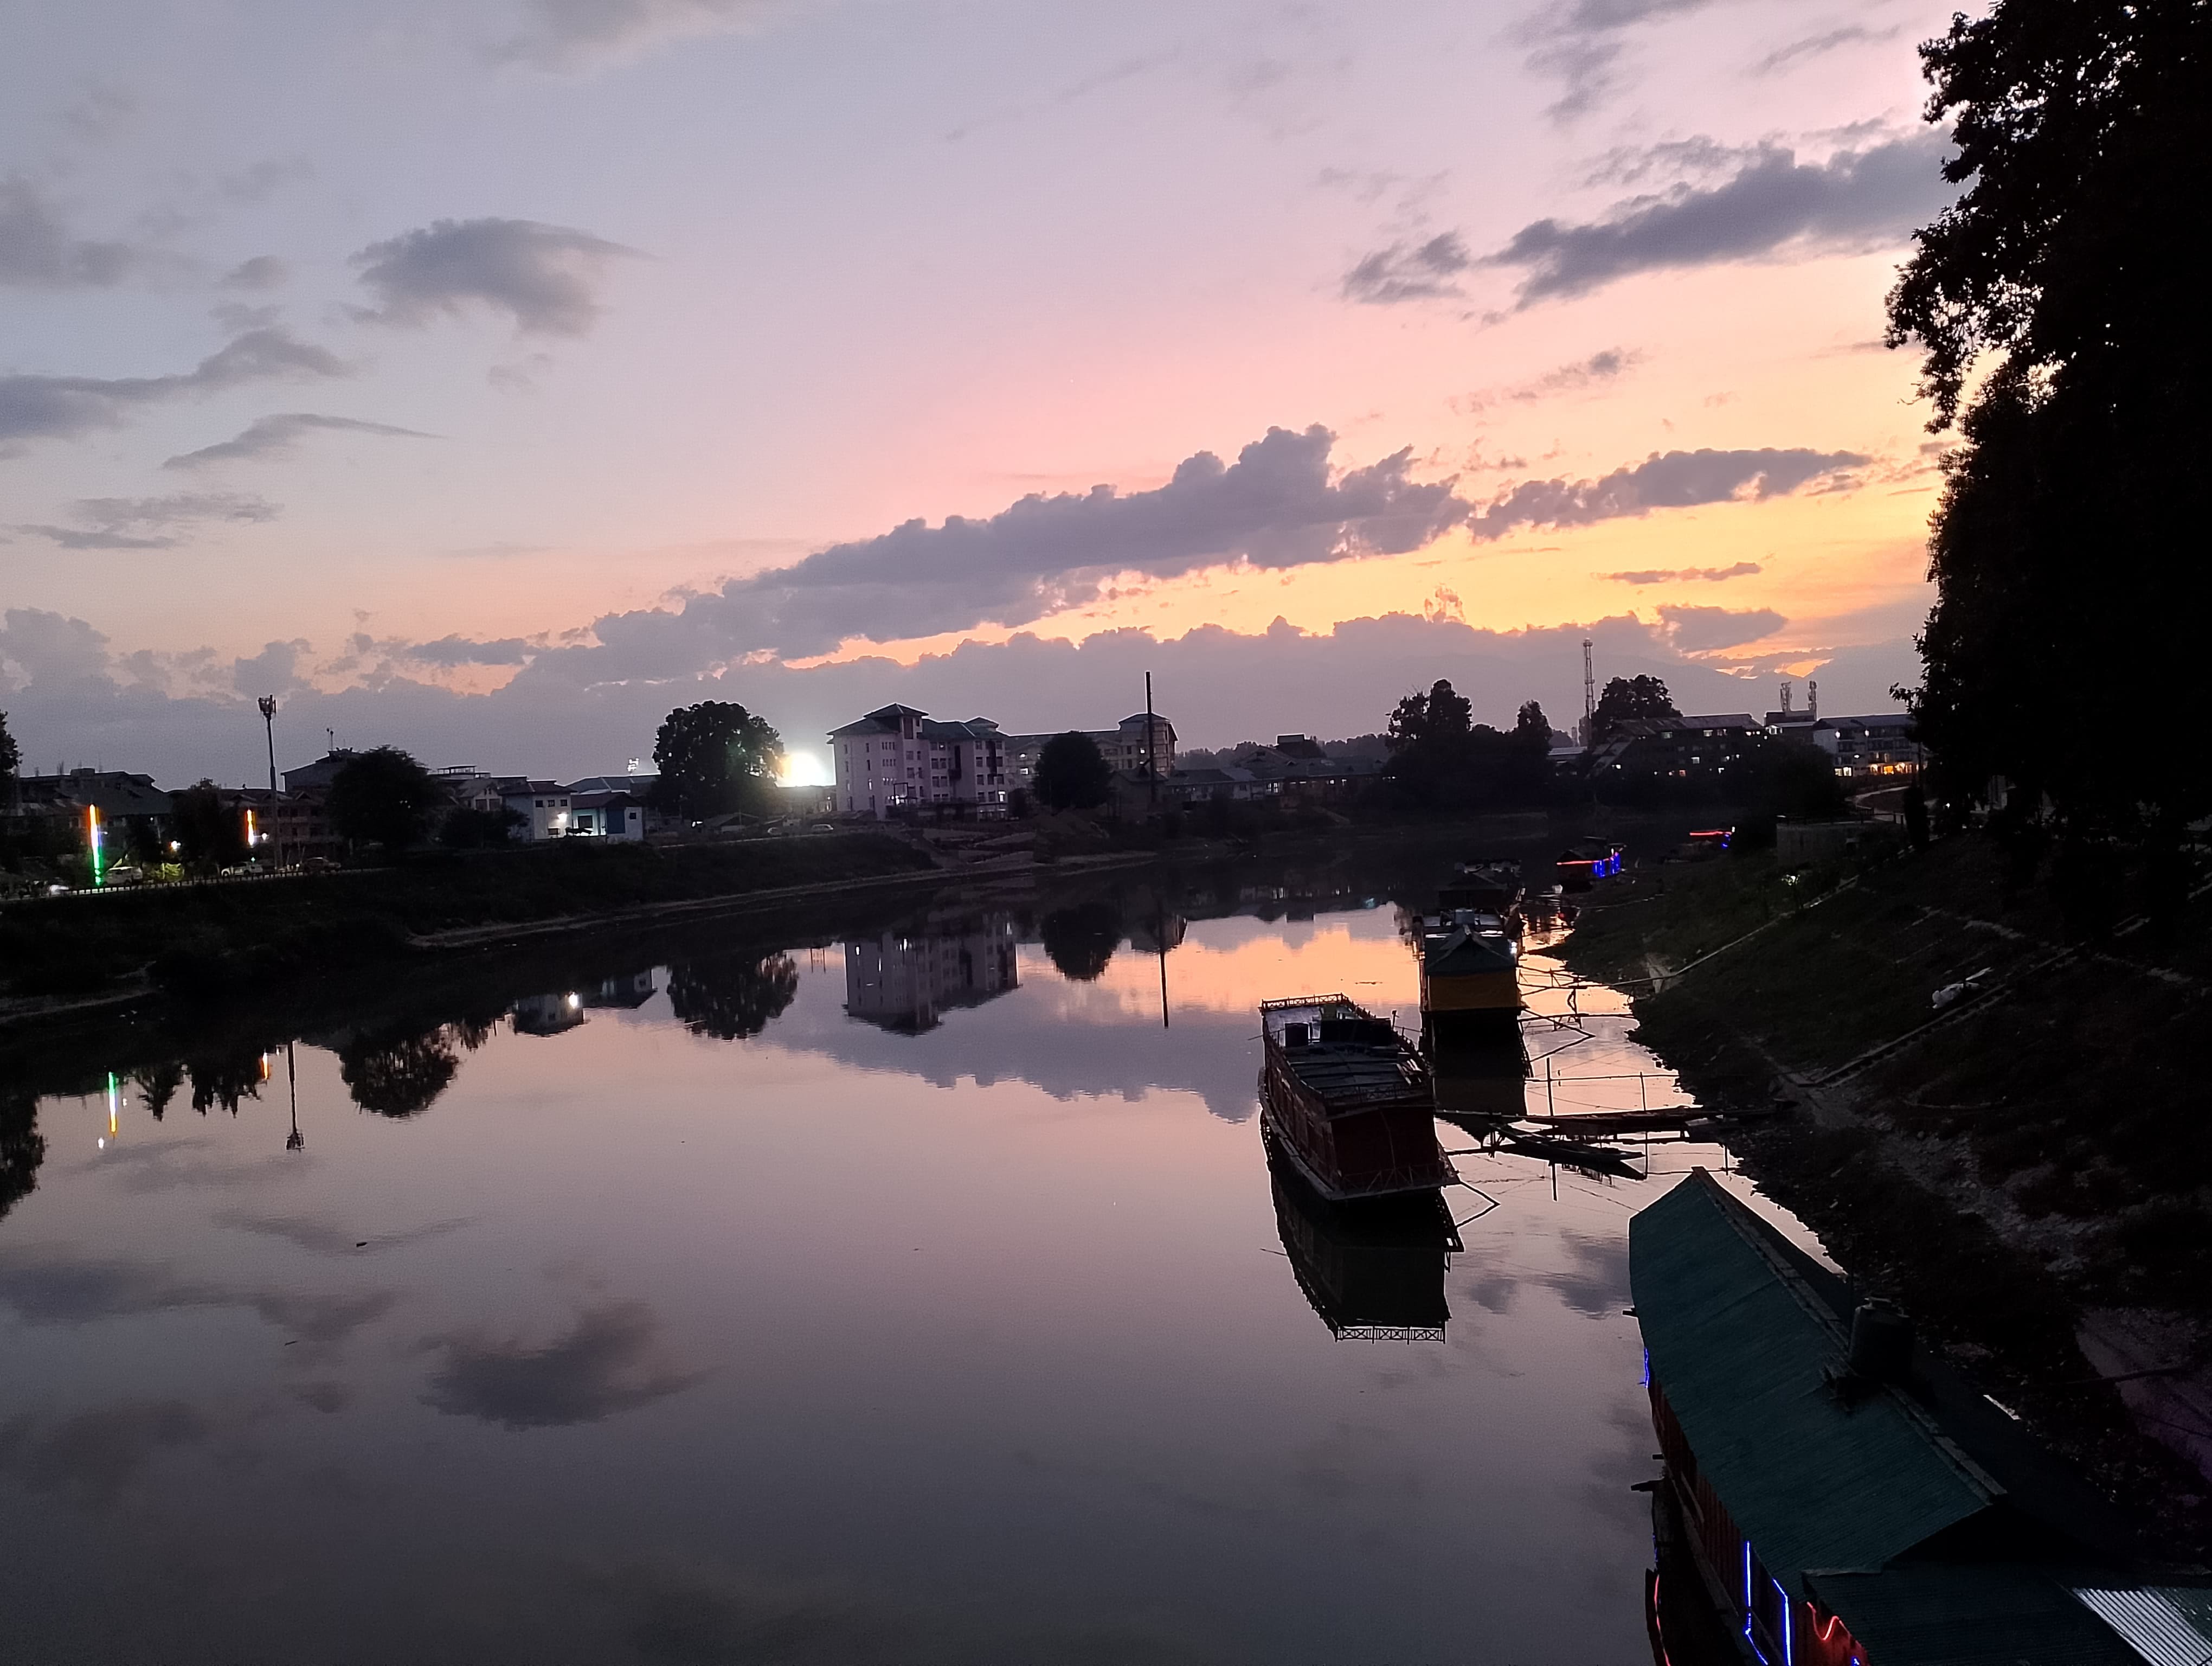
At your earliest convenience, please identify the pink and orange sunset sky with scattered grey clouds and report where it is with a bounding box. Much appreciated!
[0,0,1953,783]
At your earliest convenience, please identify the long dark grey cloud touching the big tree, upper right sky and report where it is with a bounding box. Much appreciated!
[1487,133,1953,307]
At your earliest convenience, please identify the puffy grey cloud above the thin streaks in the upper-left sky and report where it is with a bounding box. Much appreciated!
[352,219,637,336]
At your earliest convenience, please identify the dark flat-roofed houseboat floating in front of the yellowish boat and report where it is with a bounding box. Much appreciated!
[1259,996,1458,1201]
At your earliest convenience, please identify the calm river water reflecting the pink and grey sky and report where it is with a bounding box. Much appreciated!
[0,858,1814,1666]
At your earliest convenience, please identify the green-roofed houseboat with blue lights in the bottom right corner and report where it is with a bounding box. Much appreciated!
[1628,1168,2212,1666]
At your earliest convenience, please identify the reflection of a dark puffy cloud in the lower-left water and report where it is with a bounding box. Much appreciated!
[422,1301,701,1429]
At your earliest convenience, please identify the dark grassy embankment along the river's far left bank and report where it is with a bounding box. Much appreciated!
[0,832,936,996]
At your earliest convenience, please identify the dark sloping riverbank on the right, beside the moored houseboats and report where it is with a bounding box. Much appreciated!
[1566,836,2212,1553]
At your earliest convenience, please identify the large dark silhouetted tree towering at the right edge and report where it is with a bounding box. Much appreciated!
[1889,0,2212,832]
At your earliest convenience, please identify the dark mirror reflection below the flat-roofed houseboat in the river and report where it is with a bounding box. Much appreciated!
[1261,1124,1460,1343]
